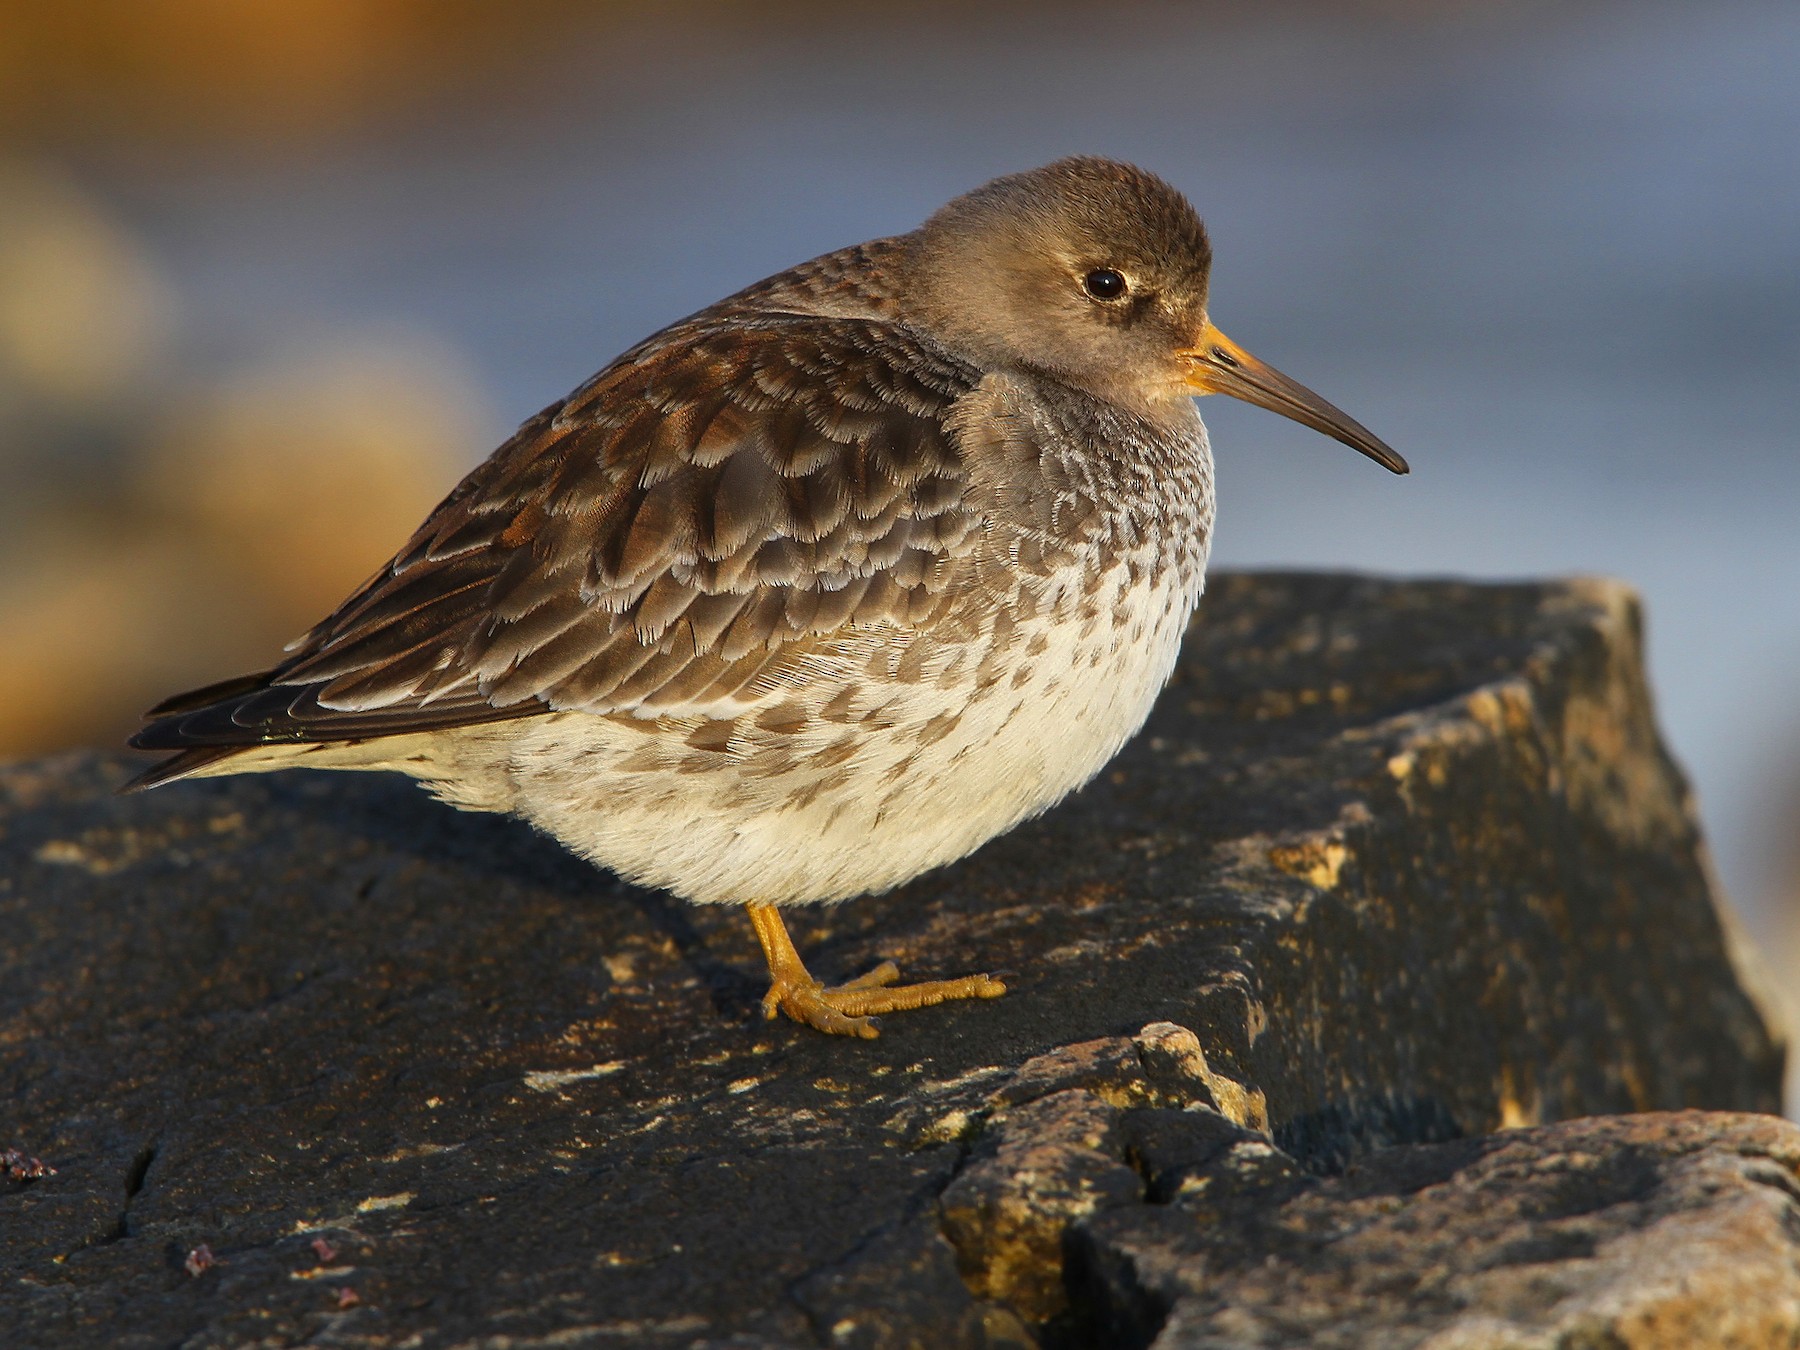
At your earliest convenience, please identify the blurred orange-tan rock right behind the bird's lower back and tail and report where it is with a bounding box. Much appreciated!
[0,340,488,756]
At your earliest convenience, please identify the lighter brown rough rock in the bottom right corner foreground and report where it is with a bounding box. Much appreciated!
[1075,1112,1800,1350]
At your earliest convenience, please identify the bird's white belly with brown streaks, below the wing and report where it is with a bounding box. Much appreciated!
[493,567,1199,904]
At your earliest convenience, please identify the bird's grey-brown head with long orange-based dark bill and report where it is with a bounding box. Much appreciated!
[902,158,1408,473]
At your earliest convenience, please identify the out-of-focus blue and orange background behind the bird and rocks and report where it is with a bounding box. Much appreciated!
[0,0,1800,1101]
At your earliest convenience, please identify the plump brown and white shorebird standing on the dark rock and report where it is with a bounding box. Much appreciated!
[124,157,1408,1037]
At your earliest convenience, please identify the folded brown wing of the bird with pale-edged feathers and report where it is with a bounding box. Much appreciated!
[133,315,981,749]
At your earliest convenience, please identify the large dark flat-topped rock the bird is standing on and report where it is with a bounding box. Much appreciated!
[0,576,1800,1348]
